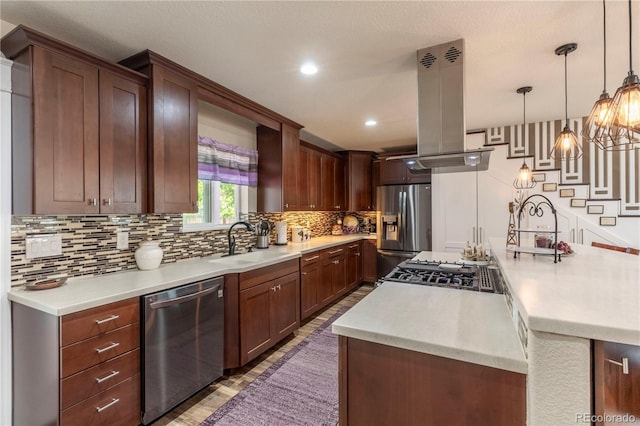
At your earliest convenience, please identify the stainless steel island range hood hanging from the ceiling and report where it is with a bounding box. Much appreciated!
[388,39,493,173]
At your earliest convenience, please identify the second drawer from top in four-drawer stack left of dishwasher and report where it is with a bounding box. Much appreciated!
[60,323,140,378]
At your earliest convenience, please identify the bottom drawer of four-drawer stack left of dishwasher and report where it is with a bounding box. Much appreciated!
[60,375,140,426]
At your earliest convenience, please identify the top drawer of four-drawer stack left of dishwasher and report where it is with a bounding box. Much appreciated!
[60,298,140,346]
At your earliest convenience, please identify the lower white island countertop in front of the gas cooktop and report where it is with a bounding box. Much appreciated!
[332,282,527,374]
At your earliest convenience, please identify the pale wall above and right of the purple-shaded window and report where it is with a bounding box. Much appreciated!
[198,102,260,212]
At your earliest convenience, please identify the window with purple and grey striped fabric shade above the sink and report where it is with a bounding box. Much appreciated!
[182,136,258,231]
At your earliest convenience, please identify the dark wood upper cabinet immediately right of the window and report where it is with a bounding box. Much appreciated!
[257,123,302,212]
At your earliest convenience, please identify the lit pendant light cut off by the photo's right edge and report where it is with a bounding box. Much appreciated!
[609,0,640,146]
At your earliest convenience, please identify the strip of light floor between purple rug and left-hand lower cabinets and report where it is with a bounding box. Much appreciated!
[153,285,373,426]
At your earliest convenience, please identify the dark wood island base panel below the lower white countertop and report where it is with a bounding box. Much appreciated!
[338,336,526,426]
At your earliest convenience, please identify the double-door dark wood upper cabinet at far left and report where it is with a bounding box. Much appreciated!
[2,26,147,214]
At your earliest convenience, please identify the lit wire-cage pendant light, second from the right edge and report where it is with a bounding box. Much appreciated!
[582,0,614,150]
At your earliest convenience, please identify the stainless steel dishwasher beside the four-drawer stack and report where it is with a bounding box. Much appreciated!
[142,277,224,424]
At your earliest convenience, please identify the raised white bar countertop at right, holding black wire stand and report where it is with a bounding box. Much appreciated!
[490,239,640,345]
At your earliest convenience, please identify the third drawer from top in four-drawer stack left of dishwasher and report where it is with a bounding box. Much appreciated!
[60,349,140,410]
